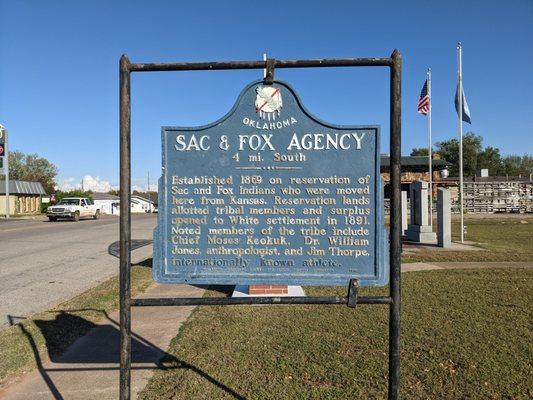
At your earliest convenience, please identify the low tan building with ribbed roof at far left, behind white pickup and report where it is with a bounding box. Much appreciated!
[0,180,46,215]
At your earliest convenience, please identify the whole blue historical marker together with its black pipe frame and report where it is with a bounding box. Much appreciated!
[120,51,401,399]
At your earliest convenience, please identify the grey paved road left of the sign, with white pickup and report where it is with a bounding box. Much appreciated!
[0,214,156,329]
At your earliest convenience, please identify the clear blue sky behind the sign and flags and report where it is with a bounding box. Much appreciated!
[0,0,533,191]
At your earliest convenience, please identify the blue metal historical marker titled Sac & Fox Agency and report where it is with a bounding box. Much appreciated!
[153,81,388,286]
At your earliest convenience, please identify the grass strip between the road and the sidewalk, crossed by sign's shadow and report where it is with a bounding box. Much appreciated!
[0,262,153,386]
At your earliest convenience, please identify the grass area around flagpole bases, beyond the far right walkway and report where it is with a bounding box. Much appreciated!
[402,214,533,262]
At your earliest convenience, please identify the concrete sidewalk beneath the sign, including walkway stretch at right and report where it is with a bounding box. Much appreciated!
[0,262,533,400]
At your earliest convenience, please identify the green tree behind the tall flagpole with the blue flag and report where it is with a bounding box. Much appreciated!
[436,132,483,176]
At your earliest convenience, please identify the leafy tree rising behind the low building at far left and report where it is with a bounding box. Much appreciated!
[9,151,57,193]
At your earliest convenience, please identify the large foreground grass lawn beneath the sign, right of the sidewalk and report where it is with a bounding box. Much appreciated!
[140,268,533,400]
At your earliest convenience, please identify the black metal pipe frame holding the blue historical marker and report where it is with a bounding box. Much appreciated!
[119,50,402,400]
